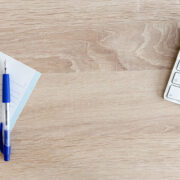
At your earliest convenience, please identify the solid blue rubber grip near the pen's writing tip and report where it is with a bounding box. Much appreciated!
[2,74,11,103]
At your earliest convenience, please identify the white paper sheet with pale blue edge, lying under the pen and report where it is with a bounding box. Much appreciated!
[0,52,41,130]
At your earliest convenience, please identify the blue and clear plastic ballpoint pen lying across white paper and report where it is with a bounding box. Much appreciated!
[2,60,11,161]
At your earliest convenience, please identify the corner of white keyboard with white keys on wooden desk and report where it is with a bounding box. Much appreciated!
[164,51,180,104]
